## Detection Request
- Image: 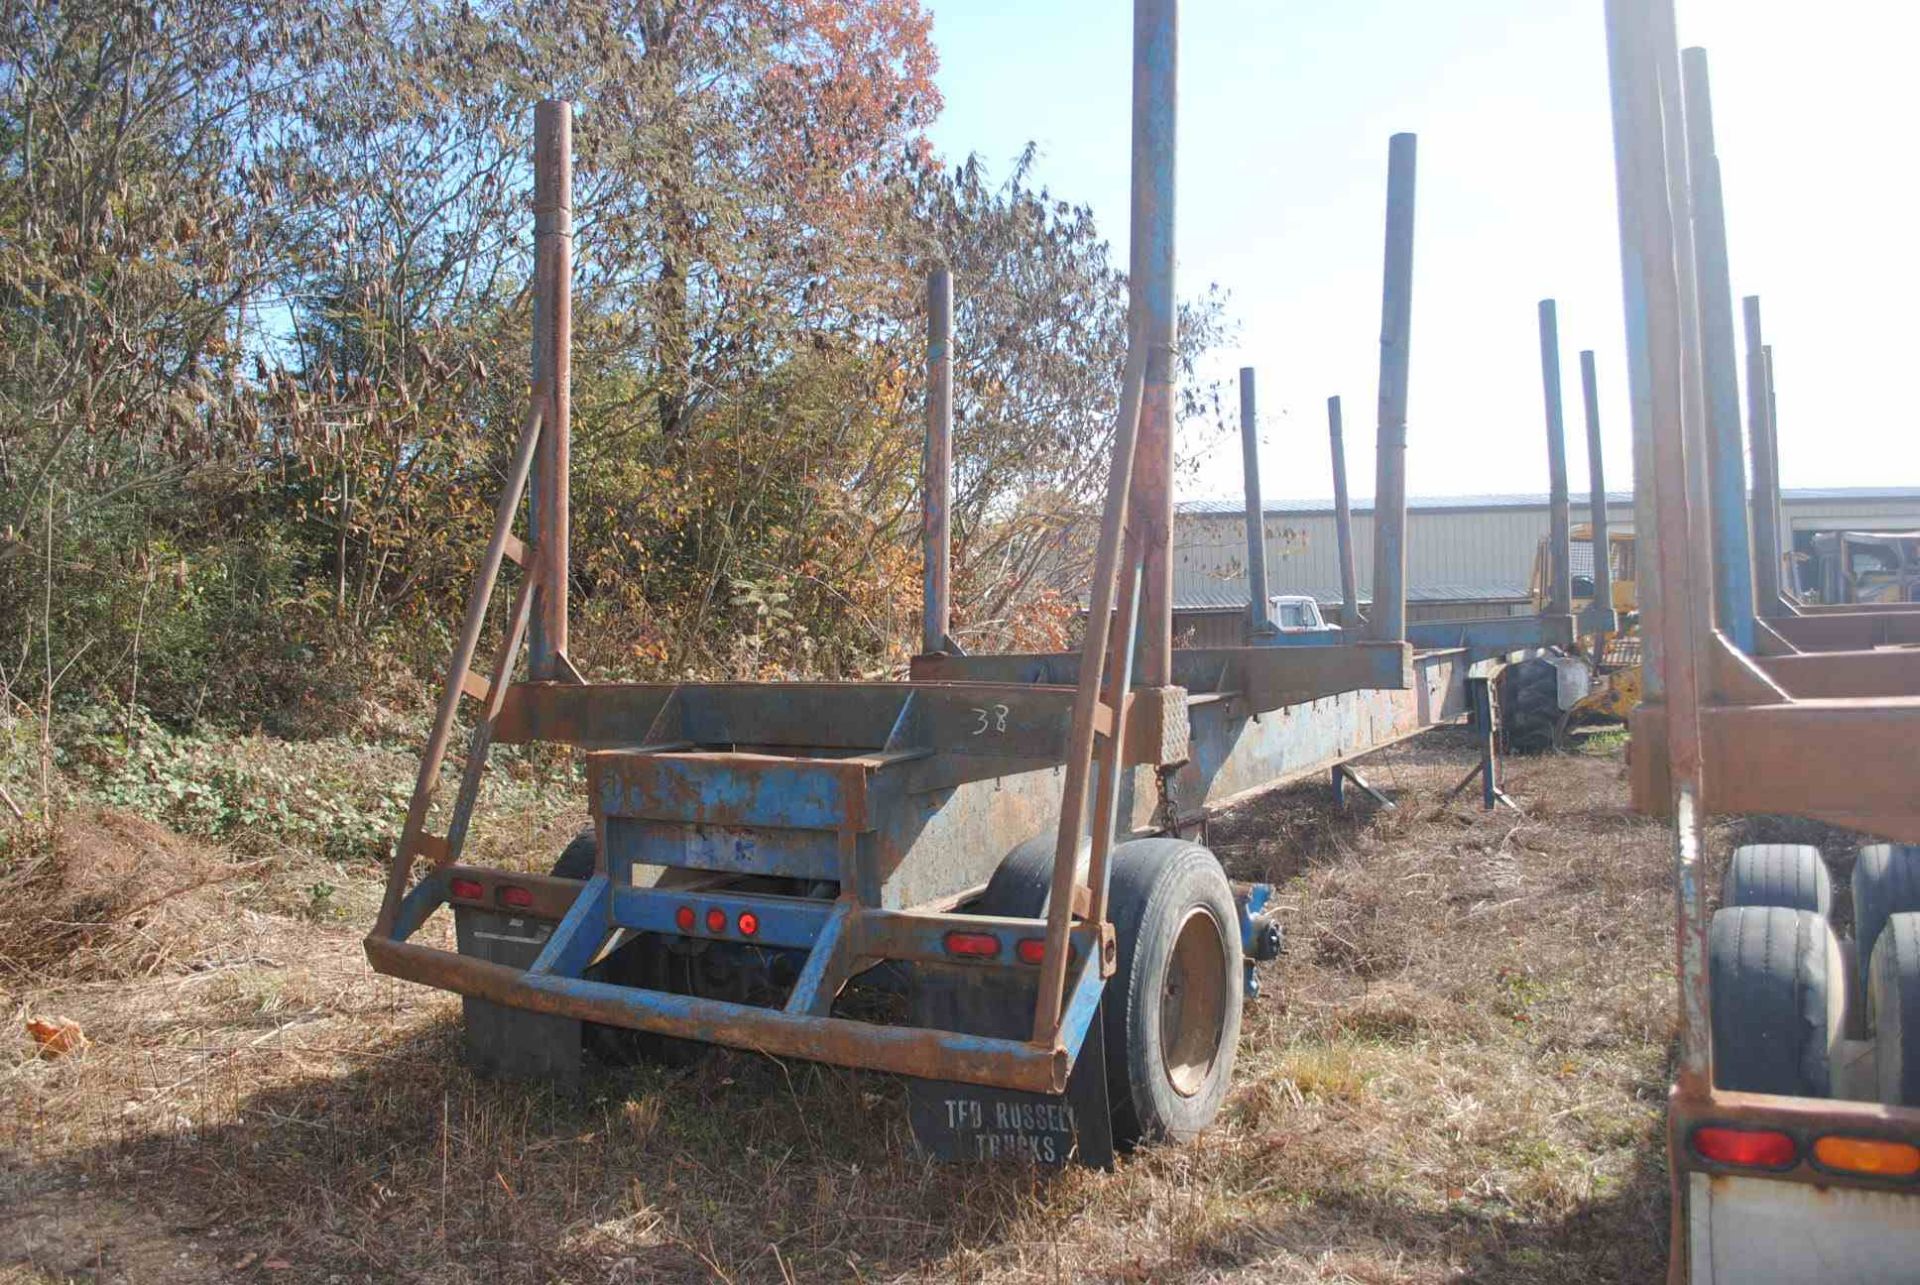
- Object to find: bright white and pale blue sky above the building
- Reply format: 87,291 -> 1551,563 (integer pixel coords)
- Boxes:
927,0 -> 1920,503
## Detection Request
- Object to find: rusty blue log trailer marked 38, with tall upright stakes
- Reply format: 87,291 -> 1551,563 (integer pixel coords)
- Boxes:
367,0 -> 1571,1164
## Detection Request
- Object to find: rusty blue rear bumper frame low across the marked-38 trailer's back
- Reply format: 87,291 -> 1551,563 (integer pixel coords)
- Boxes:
365,872 -> 1106,1093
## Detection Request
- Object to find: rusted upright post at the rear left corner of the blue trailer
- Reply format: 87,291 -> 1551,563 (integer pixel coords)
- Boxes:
528,98 -> 574,678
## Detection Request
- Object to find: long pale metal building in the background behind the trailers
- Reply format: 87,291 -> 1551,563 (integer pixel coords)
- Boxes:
1173,486 -> 1920,645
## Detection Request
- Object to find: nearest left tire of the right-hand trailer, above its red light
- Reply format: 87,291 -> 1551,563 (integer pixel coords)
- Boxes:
1709,907 -> 1847,1097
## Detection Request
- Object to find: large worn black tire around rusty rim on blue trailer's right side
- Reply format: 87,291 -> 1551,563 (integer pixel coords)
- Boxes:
1102,839 -> 1246,1147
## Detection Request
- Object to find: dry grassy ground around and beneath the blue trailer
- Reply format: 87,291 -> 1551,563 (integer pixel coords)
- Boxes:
0,732 -> 1674,1285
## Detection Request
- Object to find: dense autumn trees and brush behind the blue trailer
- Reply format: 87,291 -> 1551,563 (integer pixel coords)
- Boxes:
0,0 -> 1219,730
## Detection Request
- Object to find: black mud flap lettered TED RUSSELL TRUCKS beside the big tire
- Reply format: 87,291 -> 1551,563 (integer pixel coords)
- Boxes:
906,964 -> 1114,1170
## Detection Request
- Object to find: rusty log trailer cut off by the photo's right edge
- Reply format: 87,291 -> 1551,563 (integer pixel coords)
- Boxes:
1605,0 -> 1920,1285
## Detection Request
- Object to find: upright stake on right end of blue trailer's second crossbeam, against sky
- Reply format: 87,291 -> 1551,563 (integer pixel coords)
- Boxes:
1367,134 -> 1419,642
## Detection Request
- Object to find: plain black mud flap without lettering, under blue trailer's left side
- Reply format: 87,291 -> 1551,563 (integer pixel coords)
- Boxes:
453,907 -> 580,1093
